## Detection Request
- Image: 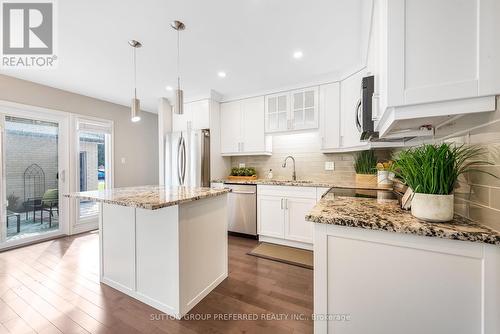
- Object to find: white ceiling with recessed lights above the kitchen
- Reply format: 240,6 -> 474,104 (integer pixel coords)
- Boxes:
0,0 -> 371,112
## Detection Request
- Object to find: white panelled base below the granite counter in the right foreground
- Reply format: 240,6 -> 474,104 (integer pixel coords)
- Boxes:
314,223 -> 500,334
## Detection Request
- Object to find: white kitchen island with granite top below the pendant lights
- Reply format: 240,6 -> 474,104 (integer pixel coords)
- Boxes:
67,186 -> 229,319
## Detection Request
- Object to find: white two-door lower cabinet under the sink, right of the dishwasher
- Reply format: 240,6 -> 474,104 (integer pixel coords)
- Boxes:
257,185 -> 317,249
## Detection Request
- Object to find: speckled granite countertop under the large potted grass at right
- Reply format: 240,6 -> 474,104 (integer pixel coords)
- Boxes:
306,190 -> 500,245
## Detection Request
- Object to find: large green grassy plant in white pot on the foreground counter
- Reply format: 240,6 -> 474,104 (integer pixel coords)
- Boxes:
394,143 -> 494,222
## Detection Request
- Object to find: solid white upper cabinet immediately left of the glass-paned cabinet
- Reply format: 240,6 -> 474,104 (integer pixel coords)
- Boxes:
220,96 -> 272,156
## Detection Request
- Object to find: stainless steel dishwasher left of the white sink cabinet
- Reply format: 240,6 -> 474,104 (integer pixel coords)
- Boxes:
224,184 -> 257,237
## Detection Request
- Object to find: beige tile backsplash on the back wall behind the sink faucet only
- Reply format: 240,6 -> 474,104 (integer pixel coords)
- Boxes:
231,132 -> 390,182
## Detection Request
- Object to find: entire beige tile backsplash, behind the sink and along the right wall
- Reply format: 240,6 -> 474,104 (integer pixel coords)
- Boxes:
231,97 -> 500,231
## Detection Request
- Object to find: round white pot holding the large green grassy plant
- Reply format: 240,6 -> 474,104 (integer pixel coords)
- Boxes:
411,193 -> 454,223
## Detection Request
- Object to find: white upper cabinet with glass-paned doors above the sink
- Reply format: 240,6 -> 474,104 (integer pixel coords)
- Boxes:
265,87 -> 319,132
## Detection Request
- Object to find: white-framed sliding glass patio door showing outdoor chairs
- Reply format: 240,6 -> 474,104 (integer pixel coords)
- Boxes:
0,106 -> 69,249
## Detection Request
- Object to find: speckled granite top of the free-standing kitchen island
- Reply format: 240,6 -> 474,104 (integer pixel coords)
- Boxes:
66,186 -> 230,210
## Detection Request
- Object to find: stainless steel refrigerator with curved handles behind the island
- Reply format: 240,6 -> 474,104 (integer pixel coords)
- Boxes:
165,129 -> 210,187
